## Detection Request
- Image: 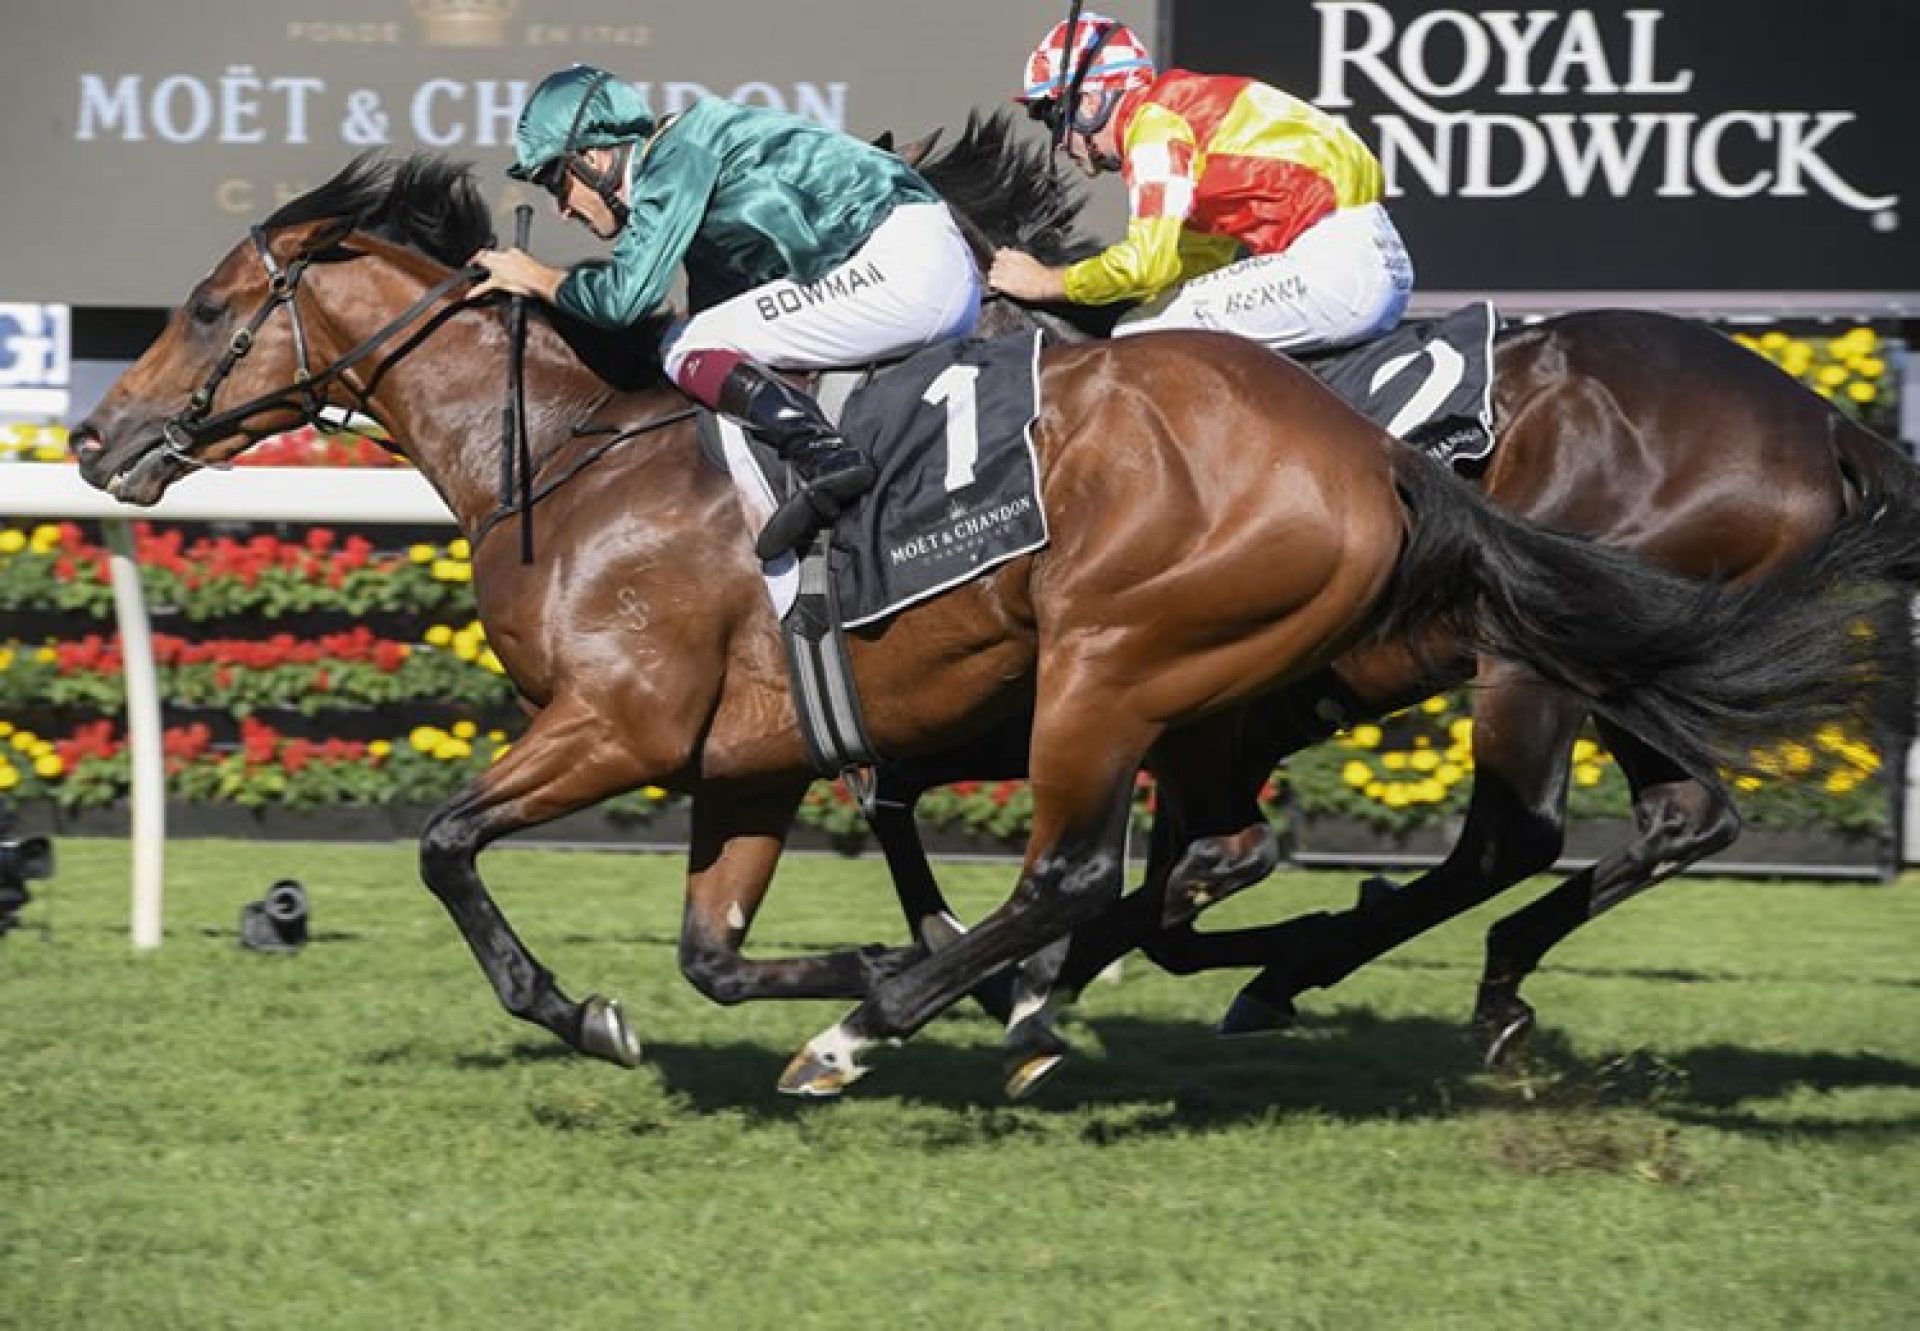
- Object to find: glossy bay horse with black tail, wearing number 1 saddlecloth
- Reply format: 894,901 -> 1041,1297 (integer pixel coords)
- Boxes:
73,157 -> 1880,1093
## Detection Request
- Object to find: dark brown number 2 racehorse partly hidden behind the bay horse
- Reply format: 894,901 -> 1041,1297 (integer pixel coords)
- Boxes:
876,113 -> 1920,1060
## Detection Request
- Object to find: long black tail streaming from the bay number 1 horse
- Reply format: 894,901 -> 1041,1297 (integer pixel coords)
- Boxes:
1382,448 -> 1907,784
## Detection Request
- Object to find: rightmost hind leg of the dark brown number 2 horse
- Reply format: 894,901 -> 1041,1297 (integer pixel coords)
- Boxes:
1473,726 -> 1740,1064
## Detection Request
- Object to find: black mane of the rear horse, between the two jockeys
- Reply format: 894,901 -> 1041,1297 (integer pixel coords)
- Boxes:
918,109 -> 1100,265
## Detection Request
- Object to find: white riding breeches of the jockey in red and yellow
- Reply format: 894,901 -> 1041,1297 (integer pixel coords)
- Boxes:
1114,204 -> 1413,351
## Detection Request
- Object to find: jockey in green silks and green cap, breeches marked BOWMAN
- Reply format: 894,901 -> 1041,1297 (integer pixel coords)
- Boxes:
462,65 -> 981,559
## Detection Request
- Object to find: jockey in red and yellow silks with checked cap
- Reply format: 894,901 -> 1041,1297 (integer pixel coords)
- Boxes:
989,13 -> 1413,351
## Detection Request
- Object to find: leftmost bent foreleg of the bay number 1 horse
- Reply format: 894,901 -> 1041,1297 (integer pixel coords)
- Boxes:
420,701 -> 647,1066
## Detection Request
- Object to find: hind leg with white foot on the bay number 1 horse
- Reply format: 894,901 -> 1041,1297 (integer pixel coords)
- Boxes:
780,668 -> 1154,1095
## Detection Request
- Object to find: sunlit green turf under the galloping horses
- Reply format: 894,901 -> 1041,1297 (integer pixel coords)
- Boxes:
0,841 -> 1920,1331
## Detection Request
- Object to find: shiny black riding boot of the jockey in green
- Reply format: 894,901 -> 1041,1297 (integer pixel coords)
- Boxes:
720,361 -> 874,559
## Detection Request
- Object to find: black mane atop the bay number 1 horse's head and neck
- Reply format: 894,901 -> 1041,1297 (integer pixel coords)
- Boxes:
265,152 -> 493,267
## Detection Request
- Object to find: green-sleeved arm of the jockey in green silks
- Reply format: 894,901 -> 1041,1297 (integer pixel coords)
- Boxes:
553,138 -> 720,328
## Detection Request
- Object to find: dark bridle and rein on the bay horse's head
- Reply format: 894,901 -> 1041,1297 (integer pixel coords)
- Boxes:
159,227 -> 486,471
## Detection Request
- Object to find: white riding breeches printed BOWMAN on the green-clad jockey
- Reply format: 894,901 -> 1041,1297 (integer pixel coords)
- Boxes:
666,204 -> 981,380
